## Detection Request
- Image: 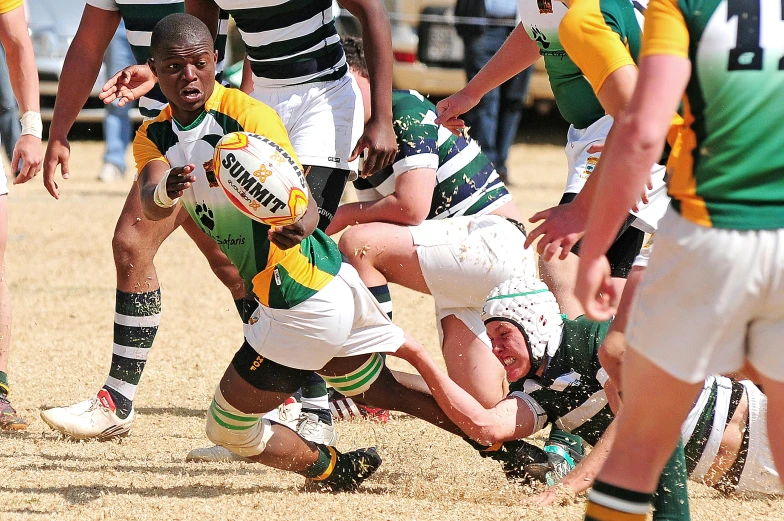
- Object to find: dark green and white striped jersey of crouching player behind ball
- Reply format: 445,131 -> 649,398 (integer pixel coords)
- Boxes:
354,90 -> 512,219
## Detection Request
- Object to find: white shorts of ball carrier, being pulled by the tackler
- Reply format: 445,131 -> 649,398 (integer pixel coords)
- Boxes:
245,263 -> 405,371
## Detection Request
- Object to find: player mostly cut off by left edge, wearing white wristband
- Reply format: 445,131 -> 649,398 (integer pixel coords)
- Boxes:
0,0 -> 43,430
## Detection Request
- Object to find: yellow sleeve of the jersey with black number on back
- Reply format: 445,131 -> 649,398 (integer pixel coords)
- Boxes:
640,0 -> 689,58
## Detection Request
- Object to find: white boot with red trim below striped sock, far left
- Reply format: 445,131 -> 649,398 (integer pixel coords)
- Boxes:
41,389 -> 135,441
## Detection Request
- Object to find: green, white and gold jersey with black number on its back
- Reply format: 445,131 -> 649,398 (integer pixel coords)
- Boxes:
641,0 -> 784,230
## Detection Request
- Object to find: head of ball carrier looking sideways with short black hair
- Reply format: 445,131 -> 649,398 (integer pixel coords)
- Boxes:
149,13 -> 217,119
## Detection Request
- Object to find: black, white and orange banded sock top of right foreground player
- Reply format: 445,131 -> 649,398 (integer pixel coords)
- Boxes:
585,480 -> 653,521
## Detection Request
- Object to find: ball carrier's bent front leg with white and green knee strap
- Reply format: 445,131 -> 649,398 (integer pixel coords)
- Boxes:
206,342 -> 381,491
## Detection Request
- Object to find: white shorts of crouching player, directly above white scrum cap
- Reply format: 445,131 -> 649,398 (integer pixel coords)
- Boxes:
408,215 -> 536,347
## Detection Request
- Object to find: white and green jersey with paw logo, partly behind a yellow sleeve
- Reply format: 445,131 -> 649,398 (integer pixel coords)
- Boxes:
517,0 -> 605,128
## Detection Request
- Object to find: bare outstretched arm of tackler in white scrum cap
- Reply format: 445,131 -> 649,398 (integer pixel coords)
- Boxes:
394,342 -> 537,445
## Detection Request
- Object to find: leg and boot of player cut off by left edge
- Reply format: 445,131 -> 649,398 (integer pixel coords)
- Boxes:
0,193 -> 27,430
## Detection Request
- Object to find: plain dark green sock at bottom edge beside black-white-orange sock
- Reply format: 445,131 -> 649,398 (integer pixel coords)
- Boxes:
653,441 -> 691,521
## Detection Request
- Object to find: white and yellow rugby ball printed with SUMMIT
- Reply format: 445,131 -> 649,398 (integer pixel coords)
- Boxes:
213,132 -> 308,226
